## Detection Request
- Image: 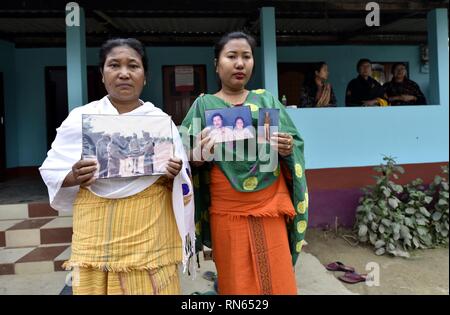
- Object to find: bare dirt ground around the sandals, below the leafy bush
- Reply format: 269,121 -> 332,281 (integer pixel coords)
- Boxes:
304,228 -> 449,295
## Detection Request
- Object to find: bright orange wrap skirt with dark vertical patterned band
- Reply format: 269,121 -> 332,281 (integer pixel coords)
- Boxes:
210,166 -> 297,295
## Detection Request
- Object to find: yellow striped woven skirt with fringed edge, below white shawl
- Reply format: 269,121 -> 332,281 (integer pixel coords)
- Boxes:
64,178 -> 183,294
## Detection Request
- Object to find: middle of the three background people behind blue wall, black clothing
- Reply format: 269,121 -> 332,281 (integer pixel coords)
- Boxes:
345,59 -> 386,106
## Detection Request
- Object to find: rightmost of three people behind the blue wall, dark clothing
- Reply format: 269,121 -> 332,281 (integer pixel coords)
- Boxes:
383,62 -> 427,105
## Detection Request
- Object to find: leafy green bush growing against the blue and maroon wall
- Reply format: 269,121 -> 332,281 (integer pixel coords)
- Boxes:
355,157 -> 448,257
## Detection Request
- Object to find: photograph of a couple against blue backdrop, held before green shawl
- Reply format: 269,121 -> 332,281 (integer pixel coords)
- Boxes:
205,106 -> 255,143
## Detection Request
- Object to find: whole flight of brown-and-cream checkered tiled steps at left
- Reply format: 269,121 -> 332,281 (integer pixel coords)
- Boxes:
0,203 -> 72,275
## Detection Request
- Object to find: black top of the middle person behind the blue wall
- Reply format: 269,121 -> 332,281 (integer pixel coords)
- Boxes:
345,76 -> 384,106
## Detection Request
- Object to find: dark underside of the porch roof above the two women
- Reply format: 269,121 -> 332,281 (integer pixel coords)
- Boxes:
0,0 -> 442,46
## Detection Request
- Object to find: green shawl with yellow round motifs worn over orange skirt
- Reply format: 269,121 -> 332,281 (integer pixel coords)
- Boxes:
182,89 -> 308,264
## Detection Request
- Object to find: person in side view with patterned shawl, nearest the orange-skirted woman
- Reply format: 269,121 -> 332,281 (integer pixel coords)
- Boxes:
300,62 -> 336,107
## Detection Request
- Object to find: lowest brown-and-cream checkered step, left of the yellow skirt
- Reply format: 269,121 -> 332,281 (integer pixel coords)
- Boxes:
0,244 -> 70,275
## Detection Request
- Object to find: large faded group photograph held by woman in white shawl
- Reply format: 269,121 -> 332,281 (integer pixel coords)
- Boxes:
82,115 -> 174,179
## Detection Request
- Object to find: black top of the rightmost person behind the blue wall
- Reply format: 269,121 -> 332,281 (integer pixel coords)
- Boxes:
383,78 -> 427,105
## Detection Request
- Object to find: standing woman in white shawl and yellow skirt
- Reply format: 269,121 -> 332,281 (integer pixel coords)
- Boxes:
40,39 -> 195,294
